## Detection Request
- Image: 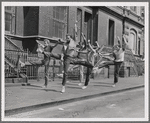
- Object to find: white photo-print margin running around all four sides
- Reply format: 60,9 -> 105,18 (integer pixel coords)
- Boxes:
1,1 -> 149,122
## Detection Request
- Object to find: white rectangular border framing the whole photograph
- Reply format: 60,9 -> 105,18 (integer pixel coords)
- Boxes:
1,0 -> 149,122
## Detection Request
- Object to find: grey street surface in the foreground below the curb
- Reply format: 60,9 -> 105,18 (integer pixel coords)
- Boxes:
6,88 -> 145,118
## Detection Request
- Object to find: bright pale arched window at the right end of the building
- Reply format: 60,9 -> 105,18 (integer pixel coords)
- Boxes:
129,29 -> 138,54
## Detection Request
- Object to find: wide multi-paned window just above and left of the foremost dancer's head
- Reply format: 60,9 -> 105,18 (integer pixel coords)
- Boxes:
53,6 -> 67,39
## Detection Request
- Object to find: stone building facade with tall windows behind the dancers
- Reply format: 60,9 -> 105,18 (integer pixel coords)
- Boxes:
5,6 -> 144,79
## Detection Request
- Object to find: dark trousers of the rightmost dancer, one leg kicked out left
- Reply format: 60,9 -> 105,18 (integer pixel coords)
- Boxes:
99,61 -> 122,83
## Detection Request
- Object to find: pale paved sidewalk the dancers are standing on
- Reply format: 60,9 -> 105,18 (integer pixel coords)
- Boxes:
5,76 -> 144,114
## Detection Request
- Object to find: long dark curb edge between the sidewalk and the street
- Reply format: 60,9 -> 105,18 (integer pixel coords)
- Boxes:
5,85 -> 144,116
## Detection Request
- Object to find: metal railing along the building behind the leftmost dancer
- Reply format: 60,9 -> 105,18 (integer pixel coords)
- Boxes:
5,49 -> 59,80
